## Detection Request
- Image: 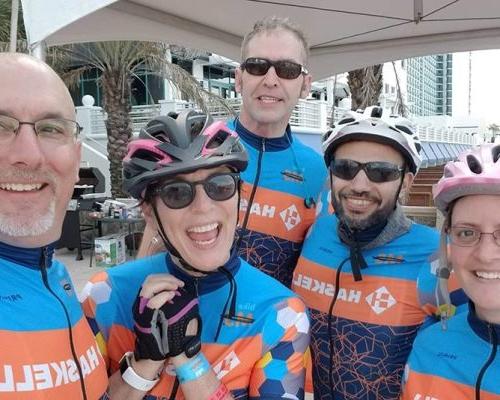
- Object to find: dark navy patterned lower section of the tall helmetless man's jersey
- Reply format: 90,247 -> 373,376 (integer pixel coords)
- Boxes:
237,229 -> 302,287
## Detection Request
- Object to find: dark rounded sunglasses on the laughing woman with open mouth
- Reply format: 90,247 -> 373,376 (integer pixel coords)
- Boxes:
153,172 -> 240,209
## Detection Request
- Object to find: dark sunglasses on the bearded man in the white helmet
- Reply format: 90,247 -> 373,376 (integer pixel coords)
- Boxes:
330,159 -> 404,183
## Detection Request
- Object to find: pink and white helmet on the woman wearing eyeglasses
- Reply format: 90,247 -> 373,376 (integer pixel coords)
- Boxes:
432,144 -> 500,213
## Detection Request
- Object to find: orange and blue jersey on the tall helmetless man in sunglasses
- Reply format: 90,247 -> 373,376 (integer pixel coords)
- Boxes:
228,120 -> 326,287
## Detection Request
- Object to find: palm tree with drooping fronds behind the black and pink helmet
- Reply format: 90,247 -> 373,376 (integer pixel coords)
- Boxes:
53,41 -> 232,197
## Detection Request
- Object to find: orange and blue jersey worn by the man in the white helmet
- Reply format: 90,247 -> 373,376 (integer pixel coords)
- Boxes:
292,208 -> 444,400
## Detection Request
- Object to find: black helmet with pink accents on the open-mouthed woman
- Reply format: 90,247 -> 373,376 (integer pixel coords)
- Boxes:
123,110 -> 248,199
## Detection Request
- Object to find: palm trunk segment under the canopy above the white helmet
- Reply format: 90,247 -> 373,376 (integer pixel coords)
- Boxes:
347,64 -> 383,110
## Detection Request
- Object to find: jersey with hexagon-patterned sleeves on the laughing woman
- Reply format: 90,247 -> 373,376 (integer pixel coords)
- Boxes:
83,253 -> 309,400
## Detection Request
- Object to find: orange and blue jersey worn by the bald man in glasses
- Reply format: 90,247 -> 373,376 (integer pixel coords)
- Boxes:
0,243 -> 108,400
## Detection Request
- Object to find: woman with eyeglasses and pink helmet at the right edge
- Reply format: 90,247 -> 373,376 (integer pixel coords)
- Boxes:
402,144 -> 500,400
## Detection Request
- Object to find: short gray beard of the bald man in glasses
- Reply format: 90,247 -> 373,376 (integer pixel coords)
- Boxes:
0,199 -> 56,237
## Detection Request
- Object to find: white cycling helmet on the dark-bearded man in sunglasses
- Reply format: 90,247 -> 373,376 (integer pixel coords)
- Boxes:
322,107 -> 422,174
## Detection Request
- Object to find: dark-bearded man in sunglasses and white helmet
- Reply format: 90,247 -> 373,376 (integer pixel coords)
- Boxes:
292,108 -> 438,400
